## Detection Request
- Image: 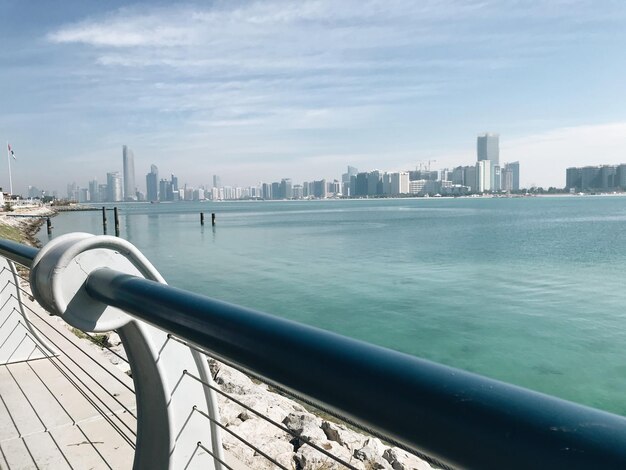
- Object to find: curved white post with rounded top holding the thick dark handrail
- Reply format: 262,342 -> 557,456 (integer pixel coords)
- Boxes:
30,233 -> 223,470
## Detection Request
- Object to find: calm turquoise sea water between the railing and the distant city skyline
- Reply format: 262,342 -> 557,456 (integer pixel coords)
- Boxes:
40,197 -> 626,415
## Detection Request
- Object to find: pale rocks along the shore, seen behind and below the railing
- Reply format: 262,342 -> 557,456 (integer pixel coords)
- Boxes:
0,207 -> 433,470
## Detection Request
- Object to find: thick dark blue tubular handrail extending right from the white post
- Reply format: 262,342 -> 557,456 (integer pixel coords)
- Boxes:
0,241 -> 626,469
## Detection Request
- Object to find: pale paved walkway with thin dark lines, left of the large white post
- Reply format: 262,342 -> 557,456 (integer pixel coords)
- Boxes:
0,284 -> 136,470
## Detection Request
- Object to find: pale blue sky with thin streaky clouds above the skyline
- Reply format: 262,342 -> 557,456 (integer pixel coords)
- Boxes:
0,0 -> 626,194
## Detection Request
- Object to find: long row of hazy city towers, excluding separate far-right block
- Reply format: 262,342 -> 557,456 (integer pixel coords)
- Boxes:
61,133 -> 520,203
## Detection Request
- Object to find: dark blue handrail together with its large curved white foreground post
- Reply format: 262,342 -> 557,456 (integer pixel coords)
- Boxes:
0,234 -> 626,469
